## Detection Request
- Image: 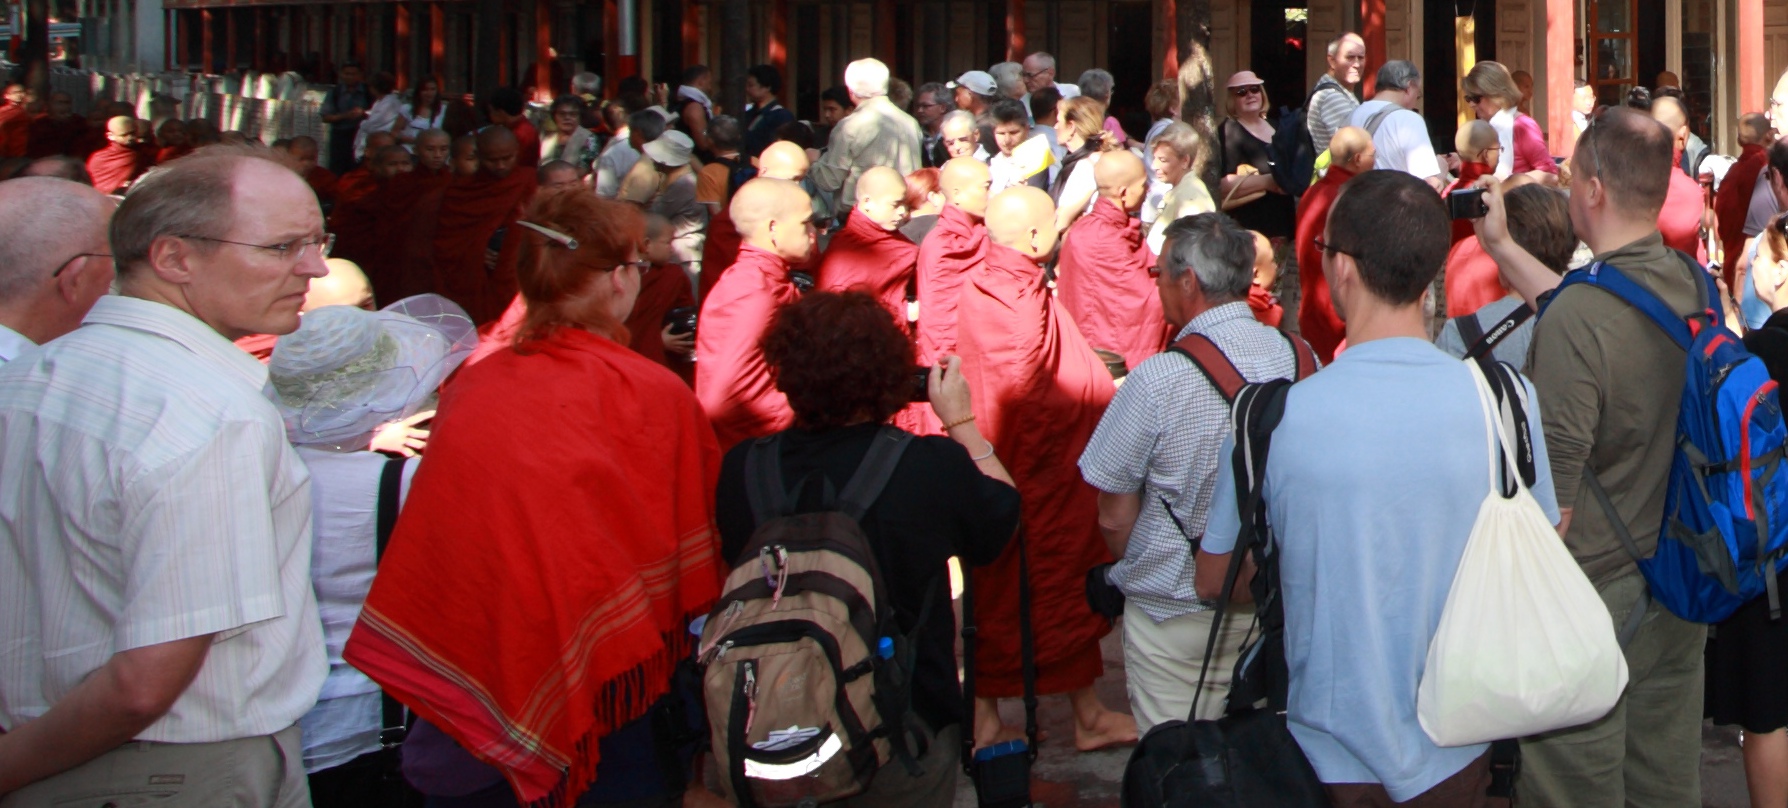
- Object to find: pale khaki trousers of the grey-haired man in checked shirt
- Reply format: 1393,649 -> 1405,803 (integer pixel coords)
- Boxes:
1123,602 -> 1253,735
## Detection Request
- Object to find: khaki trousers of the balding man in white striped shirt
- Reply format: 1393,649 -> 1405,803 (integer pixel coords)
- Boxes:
0,724 -> 311,808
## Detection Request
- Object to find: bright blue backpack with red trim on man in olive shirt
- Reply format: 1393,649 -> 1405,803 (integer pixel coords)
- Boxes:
1554,254 -> 1788,625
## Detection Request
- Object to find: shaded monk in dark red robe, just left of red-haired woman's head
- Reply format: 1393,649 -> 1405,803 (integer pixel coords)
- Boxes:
433,127 -> 535,325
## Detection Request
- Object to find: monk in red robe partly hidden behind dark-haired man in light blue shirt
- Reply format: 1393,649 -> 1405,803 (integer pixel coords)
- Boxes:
1296,127 -> 1379,365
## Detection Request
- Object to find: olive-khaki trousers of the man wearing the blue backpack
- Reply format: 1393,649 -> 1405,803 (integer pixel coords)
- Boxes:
1516,570 -> 1708,808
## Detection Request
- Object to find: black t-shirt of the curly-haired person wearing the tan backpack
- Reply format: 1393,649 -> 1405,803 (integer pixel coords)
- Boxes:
715,424 -> 1019,729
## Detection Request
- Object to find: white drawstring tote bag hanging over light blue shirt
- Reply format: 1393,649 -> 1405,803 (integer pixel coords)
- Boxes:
1416,361 -> 1627,745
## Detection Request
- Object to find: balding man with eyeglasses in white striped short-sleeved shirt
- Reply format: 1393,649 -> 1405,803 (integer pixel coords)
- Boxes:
0,147 -> 329,808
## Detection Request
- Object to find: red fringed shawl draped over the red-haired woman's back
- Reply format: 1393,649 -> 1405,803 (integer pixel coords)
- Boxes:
343,329 -> 726,806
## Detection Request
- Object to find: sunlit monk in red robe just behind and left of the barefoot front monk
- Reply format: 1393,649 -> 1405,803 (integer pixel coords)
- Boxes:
917,157 -> 992,370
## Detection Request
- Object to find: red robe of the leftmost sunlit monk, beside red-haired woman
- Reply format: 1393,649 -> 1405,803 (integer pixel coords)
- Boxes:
696,243 -> 801,450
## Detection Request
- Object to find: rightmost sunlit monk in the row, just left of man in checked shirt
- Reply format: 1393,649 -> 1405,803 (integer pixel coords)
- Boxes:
1055,152 -> 1169,368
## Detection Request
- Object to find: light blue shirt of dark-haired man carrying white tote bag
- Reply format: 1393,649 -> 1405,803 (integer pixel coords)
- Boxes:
1203,338 -> 1559,803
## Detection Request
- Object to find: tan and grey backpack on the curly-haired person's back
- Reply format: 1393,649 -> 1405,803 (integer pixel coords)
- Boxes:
701,427 -> 937,808
